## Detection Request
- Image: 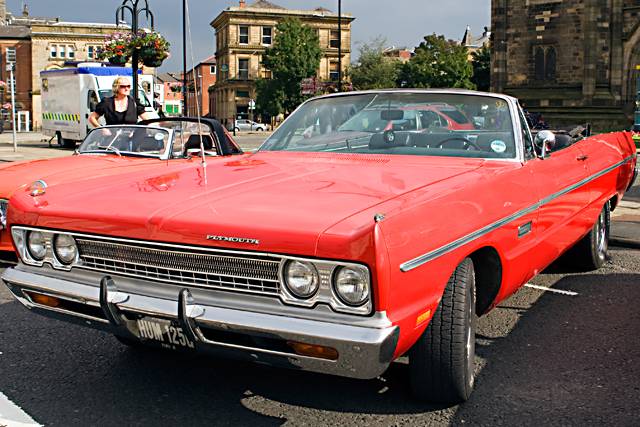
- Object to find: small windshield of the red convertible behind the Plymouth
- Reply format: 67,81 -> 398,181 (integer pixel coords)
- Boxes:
79,126 -> 169,157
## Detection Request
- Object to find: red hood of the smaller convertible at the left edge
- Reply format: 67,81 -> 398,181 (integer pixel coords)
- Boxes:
0,154 -> 168,199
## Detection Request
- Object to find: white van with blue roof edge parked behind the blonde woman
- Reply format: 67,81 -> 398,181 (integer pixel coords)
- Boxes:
40,63 -> 158,148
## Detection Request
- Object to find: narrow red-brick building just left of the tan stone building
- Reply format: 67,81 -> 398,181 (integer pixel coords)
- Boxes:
186,56 -> 217,117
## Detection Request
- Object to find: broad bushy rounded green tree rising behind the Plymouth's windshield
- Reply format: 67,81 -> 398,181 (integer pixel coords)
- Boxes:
398,34 -> 475,89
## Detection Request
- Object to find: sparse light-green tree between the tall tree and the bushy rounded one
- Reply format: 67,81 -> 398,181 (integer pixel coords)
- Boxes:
347,37 -> 400,90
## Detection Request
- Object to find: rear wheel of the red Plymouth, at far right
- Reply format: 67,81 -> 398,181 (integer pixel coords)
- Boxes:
572,202 -> 611,270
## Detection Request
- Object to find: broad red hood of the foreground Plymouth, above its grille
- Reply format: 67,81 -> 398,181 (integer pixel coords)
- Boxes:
10,152 -> 483,254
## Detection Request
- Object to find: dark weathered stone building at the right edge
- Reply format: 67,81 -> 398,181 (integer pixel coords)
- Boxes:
491,0 -> 640,129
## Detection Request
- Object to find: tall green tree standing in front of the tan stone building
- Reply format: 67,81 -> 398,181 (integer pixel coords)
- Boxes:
258,18 -> 322,112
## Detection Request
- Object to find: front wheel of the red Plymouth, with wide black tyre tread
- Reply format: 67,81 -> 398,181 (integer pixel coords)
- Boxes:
409,258 -> 476,403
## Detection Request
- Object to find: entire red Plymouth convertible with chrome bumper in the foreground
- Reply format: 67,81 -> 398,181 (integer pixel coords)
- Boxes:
2,90 -> 637,402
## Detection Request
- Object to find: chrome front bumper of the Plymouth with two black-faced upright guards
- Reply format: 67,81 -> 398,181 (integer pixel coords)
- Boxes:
2,267 -> 399,378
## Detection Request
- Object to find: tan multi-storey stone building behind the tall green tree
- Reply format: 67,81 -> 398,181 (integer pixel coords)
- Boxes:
211,0 -> 355,120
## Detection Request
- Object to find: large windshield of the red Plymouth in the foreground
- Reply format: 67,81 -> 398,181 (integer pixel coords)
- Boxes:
260,92 -> 516,158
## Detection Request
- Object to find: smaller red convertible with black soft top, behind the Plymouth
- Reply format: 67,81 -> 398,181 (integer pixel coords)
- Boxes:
0,117 -> 241,261
